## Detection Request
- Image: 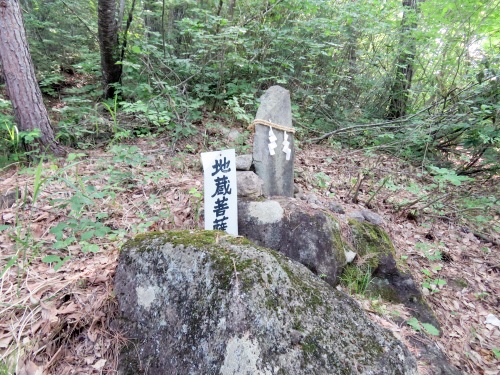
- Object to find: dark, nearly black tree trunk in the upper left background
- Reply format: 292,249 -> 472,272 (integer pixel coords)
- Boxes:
97,0 -> 122,99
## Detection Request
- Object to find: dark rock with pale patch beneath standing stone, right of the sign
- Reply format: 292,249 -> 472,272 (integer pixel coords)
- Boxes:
238,197 -> 350,285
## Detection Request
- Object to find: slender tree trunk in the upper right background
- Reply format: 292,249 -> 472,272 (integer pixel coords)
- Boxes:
386,0 -> 419,119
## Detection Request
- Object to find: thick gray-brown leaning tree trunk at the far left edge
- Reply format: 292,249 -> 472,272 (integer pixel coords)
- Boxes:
0,0 -> 65,156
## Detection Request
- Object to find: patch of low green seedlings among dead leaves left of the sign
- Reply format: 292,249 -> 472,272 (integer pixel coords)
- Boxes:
0,145 -> 176,275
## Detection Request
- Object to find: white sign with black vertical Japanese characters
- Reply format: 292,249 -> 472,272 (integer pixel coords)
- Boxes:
201,149 -> 238,236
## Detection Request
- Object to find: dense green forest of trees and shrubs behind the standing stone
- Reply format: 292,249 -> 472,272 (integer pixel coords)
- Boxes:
0,0 -> 500,229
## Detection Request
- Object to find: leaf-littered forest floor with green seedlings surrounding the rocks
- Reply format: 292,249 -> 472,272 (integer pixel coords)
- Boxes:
0,122 -> 500,375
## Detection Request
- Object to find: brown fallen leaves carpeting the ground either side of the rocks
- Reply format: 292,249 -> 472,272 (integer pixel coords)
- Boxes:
0,140 -> 500,375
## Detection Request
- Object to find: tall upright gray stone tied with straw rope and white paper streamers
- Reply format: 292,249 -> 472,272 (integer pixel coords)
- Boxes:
253,86 -> 295,197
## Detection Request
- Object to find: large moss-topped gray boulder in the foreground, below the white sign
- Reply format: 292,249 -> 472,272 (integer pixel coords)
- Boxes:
115,231 -> 417,375
